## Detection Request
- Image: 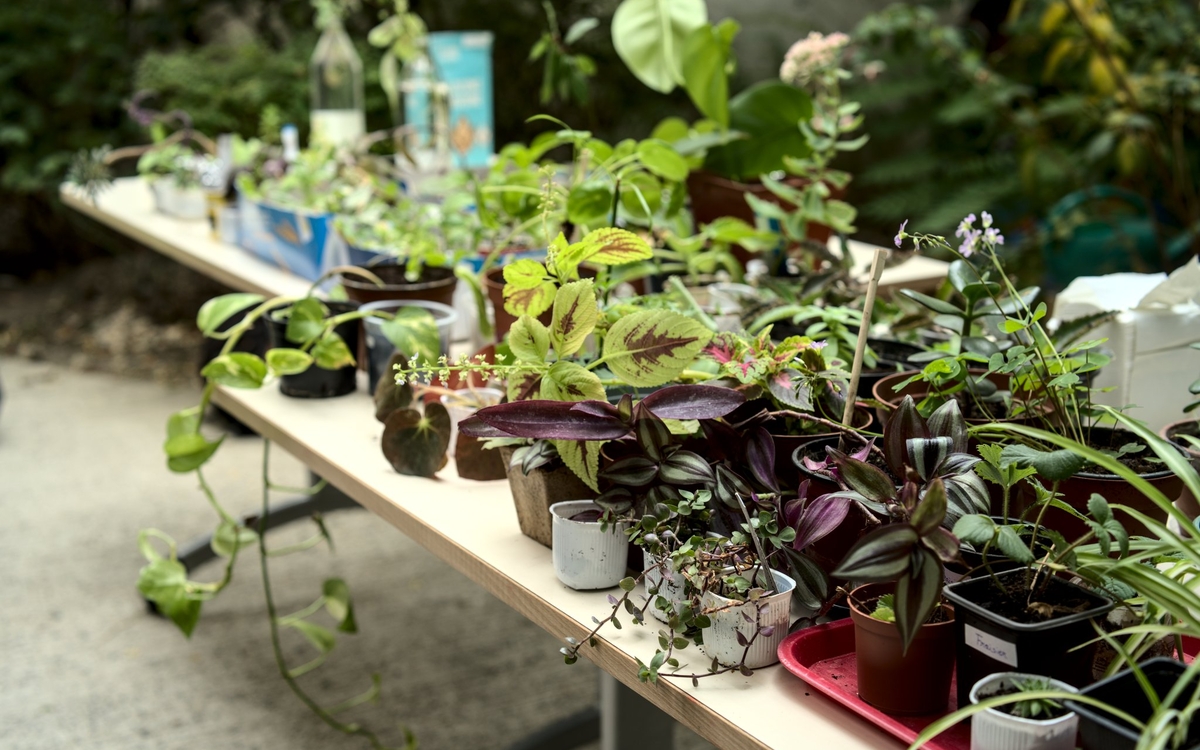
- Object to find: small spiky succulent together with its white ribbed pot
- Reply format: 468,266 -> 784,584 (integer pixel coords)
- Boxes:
971,672 -> 1079,750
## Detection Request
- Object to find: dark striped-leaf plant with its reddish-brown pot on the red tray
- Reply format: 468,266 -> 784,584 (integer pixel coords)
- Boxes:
833,470 -> 959,714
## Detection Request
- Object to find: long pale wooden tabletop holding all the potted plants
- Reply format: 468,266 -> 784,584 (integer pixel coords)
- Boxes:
64,176 -> 931,750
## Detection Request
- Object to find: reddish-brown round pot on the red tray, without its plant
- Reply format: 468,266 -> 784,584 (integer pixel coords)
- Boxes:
850,583 -> 954,715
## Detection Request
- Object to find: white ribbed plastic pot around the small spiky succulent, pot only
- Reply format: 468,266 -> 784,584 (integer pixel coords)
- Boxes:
971,672 -> 1079,750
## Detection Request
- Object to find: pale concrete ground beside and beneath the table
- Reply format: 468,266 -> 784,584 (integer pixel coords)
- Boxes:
0,358 -> 710,750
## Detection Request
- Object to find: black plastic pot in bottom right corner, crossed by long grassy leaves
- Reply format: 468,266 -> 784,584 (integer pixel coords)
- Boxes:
1067,656 -> 1200,750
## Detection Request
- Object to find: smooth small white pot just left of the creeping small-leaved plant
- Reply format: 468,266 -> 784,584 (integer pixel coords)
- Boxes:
550,500 -> 629,592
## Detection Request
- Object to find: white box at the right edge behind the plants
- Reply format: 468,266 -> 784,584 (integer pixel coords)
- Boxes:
1055,258 -> 1200,430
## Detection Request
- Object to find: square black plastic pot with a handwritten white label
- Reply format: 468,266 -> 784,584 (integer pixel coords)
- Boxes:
944,568 -> 1115,706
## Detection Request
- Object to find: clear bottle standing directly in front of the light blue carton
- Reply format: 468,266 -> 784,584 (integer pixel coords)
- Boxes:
400,42 -> 450,174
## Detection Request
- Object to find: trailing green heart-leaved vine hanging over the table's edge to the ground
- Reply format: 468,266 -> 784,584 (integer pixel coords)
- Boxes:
137,268 -> 437,750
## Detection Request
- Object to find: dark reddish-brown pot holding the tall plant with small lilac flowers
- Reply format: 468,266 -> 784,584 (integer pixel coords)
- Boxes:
1010,427 -> 1183,539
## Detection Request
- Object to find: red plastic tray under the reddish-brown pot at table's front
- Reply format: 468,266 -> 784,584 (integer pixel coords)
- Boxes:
779,618 -> 1200,750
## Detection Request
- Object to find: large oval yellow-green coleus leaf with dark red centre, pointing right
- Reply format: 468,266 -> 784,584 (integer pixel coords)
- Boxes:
604,310 -> 712,388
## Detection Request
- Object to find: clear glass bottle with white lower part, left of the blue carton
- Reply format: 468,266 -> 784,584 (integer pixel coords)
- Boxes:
308,18 -> 366,148
